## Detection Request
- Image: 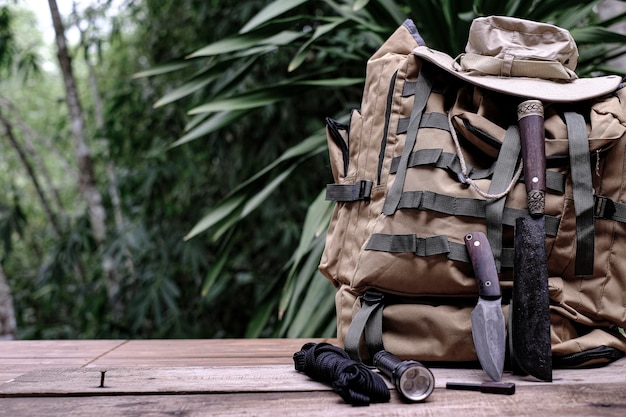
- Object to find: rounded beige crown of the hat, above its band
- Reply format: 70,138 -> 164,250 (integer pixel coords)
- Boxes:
465,16 -> 578,71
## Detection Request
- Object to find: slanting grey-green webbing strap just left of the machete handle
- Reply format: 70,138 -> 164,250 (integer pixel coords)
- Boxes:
485,125 -> 521,271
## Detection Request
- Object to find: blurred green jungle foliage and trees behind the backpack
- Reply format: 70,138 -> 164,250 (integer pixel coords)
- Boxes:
0,0 -> 626,339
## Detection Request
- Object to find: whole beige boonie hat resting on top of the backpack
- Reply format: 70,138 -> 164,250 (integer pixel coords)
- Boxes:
413,16 -> 622,102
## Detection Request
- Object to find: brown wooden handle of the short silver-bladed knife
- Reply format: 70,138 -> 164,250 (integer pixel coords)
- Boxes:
465,232 -> 501,299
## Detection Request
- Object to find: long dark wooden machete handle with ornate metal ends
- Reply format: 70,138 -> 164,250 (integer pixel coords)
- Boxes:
517,100 -> 546,216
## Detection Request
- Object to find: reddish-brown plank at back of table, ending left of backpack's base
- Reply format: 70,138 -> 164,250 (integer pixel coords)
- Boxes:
89,339 -> 336,366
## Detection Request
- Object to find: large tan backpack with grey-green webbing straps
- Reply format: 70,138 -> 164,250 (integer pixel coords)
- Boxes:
319,19 -> 626,367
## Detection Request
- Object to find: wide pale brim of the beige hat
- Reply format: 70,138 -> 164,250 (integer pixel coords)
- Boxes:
413,46 -> 622,102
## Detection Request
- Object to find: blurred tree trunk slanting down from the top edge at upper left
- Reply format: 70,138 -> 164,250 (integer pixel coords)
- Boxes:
48,0 -> 106,245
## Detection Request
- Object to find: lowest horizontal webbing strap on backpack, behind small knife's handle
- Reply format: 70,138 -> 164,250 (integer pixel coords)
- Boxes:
365,233 -> 514,268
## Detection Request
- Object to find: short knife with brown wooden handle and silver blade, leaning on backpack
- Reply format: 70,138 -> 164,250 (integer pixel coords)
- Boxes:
465,232 -> 506,382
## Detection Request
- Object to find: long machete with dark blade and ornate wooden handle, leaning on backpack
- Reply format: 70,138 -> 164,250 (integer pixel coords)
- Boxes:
509,100 -> 552,381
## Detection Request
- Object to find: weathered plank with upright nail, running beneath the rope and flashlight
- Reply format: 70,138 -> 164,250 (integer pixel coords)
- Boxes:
0,360 -> 626,396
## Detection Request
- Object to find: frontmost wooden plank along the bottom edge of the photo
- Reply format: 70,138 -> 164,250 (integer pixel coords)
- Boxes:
2,383 -> 626,417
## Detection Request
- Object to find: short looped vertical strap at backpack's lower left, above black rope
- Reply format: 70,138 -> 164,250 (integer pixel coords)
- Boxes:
344,290 -> 384,361
